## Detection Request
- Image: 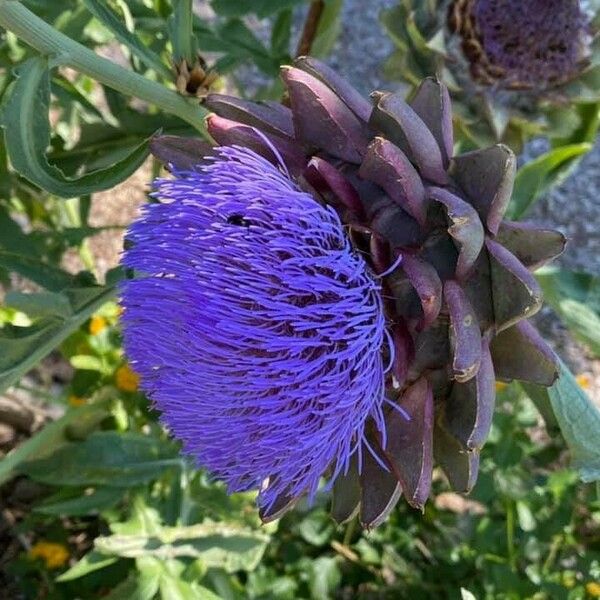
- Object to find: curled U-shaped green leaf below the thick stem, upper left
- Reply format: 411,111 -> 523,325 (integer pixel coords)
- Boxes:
0,57 -> 149,198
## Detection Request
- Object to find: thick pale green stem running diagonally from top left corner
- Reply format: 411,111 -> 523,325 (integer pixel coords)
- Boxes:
0,0 -> 208,138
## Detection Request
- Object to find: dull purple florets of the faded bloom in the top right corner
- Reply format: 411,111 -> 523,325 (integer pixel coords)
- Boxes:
474,0 -> 588,87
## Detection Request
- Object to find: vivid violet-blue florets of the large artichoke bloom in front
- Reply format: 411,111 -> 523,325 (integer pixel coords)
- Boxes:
122,147 -> 385,507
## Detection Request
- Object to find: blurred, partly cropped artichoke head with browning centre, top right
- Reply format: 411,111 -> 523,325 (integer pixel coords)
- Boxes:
382,0 -> 600,150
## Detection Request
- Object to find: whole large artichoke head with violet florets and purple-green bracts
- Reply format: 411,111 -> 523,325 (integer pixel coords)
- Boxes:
122,58 -> 564,527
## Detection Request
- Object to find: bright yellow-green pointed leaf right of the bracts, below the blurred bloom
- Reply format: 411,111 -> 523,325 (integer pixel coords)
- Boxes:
508,143 -> 592,220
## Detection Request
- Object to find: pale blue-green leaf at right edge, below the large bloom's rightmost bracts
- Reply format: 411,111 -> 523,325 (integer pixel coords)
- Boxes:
548,361 -> 600,482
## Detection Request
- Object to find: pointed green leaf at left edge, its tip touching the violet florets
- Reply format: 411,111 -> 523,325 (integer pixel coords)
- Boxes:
0,278 -> 116,393
